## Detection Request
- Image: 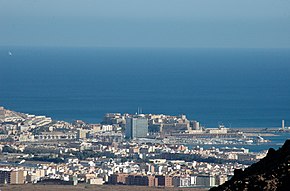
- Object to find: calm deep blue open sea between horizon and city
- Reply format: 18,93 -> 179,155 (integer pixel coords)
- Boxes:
0,47 -> 290,127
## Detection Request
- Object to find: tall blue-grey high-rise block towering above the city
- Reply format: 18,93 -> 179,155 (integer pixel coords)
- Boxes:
125,116 -> 148,139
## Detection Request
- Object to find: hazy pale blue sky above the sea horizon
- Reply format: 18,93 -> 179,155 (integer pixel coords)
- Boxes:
0,0 -> 290,48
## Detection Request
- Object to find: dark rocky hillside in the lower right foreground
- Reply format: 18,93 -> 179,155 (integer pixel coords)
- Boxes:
210,140 -> 290,191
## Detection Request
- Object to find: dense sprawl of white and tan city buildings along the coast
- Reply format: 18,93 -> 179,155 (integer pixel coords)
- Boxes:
0,107 -> 265,187
